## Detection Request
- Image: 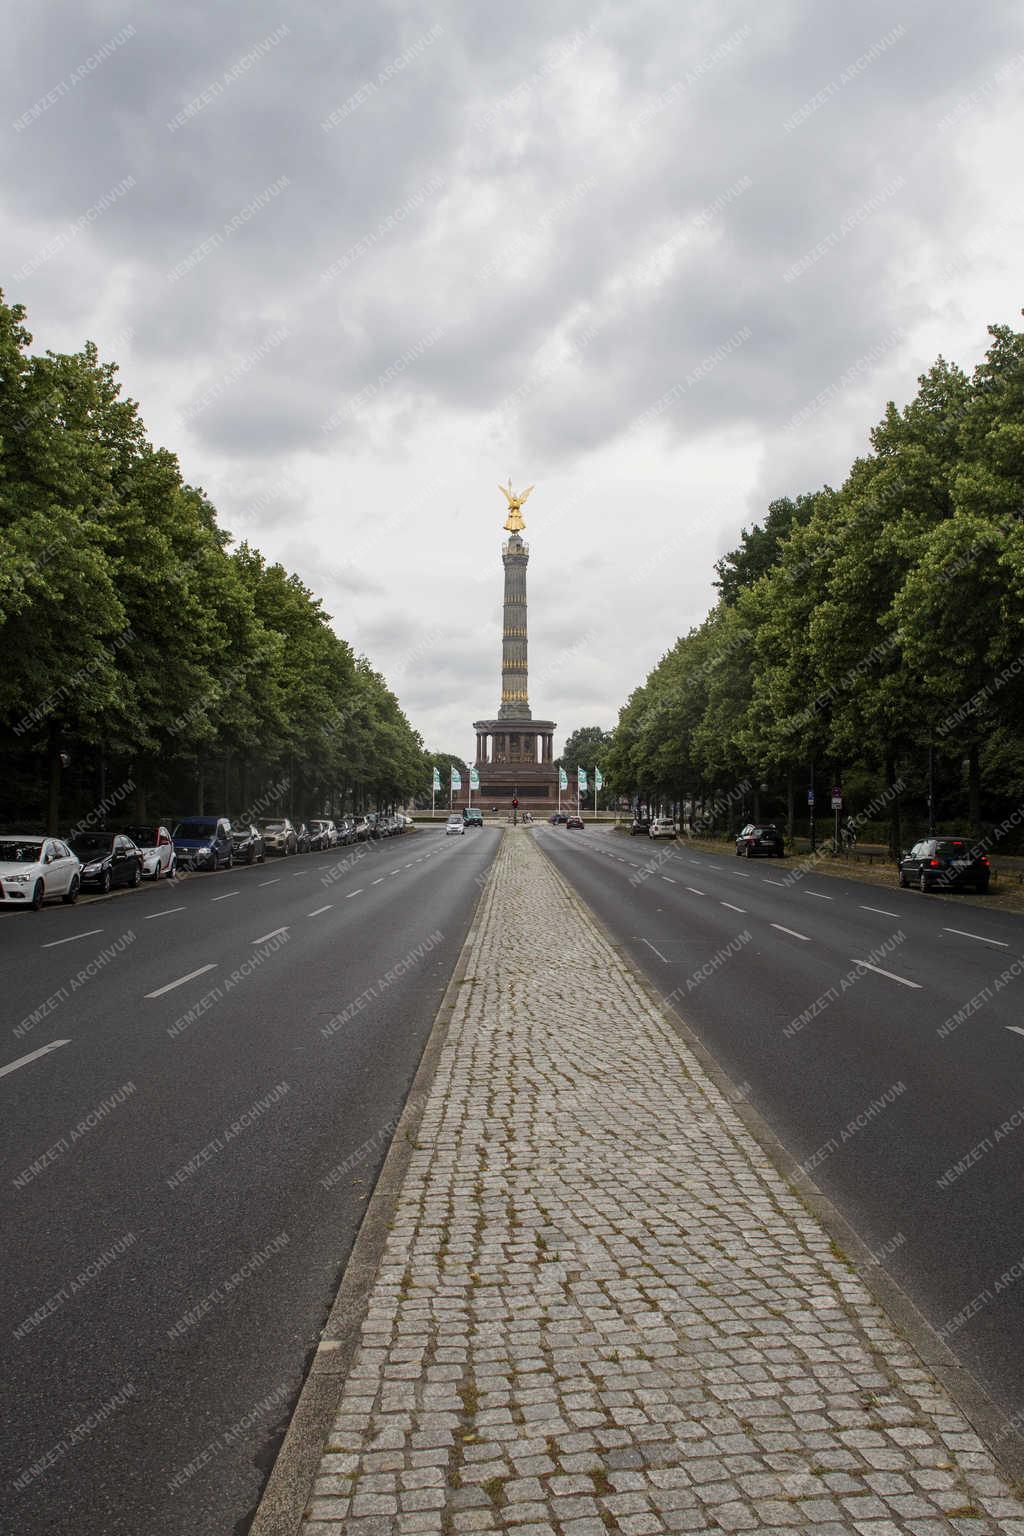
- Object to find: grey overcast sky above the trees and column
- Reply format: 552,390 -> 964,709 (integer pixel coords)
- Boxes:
0,0 -> 1024,754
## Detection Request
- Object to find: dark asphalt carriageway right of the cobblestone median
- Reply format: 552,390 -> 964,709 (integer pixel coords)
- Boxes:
534,826 -> 1024,1415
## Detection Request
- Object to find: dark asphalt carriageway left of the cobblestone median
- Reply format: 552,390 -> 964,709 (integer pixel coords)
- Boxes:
0,828 -> 499,1536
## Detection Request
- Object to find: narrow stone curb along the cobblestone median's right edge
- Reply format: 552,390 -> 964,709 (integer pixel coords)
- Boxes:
534,837 -> 1024,1490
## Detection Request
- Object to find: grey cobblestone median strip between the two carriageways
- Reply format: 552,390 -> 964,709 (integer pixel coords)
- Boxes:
301,833 -> 1024,1536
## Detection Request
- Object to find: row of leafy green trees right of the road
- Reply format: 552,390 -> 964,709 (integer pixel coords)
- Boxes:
608,311 -> 1024,851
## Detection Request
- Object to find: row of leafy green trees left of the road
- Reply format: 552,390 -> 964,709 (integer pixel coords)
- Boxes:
0,293 -> 430,831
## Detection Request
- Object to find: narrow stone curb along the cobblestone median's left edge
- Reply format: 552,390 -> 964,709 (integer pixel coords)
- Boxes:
249,834 -> 504,1536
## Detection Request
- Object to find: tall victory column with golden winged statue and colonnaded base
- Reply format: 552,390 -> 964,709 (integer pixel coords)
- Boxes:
454,481 -> 559,814
